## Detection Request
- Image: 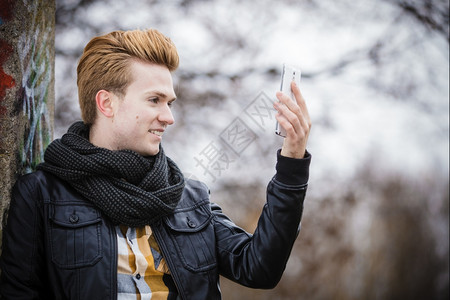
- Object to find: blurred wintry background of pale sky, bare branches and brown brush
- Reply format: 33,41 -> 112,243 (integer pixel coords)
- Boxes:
55,0 -> 449,300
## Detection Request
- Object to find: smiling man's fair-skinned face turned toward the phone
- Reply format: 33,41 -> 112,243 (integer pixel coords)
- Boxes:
111,61 -> 176,156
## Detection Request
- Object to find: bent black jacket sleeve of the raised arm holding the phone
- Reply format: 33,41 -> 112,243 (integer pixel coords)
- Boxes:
212,152 -> 311,288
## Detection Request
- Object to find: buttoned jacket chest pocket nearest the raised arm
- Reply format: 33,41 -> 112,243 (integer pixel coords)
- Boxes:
164,207 -> 217,272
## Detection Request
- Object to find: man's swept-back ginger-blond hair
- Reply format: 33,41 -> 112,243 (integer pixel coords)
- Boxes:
77,29 -> 179,125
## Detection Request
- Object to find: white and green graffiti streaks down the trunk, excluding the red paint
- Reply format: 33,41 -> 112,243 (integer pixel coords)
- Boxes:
17,0 -> 53,172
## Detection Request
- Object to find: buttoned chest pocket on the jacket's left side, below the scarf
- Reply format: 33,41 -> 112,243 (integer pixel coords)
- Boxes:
49,204 -> 102,269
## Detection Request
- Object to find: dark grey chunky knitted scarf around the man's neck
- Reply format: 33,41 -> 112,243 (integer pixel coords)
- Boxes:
38,122 -> 184,227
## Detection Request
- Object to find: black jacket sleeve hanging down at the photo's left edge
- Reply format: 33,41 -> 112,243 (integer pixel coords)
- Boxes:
0,175 -> 46,299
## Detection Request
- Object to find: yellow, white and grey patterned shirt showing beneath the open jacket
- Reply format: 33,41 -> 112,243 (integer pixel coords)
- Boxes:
116,226 -> 179,300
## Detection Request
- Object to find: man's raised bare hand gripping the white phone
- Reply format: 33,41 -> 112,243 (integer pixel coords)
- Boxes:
274,82 -> 311,158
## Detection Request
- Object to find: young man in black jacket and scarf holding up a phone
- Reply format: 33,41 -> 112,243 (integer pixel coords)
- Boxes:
0,30 -> 311,299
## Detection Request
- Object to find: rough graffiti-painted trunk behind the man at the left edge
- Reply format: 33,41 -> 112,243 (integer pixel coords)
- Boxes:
0,0 -> 55,249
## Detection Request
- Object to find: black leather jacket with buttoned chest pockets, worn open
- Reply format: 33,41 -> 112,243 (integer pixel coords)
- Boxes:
0,154 -> 309,299
